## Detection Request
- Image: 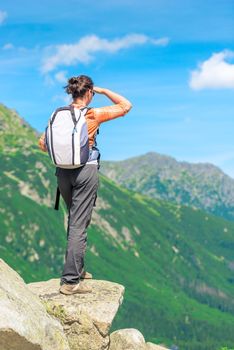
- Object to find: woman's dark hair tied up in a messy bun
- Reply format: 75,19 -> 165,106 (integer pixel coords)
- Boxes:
64,75 -> 93,99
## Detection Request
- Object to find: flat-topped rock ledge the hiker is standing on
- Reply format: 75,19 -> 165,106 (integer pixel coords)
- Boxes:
28,279 -> 124,350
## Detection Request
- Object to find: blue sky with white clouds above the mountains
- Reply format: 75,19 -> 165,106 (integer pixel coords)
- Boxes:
0,0 -> 234,177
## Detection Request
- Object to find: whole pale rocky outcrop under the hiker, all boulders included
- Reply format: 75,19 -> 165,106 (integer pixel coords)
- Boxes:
0,259 -> 168,350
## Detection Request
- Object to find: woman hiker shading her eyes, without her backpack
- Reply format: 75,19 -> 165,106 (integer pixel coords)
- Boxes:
39,75 -> 132,294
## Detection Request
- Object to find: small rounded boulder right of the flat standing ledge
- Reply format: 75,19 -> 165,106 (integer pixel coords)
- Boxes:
109,328 -> 147,350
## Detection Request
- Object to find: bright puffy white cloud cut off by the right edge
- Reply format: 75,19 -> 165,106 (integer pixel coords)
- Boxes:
189,50 -> 234,90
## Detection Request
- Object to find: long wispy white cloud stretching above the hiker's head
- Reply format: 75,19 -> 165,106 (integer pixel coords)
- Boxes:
42,34 -> 168,73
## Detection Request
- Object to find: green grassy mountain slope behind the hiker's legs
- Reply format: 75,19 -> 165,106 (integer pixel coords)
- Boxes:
0,105 -> 234,350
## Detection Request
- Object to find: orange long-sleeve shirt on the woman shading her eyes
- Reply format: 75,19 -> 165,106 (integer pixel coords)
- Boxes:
38,98 -> 132,152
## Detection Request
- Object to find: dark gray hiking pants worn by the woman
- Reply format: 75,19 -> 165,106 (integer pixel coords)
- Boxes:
55,164 -> 99,285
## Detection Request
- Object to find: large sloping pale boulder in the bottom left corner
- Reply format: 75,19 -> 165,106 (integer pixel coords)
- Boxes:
0,259 -> 69,350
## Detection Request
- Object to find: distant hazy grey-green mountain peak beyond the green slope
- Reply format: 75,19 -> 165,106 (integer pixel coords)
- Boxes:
100,152 -> 234,220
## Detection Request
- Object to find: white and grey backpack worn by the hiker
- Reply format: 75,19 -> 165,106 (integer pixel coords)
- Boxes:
45,106 -> 90,169
